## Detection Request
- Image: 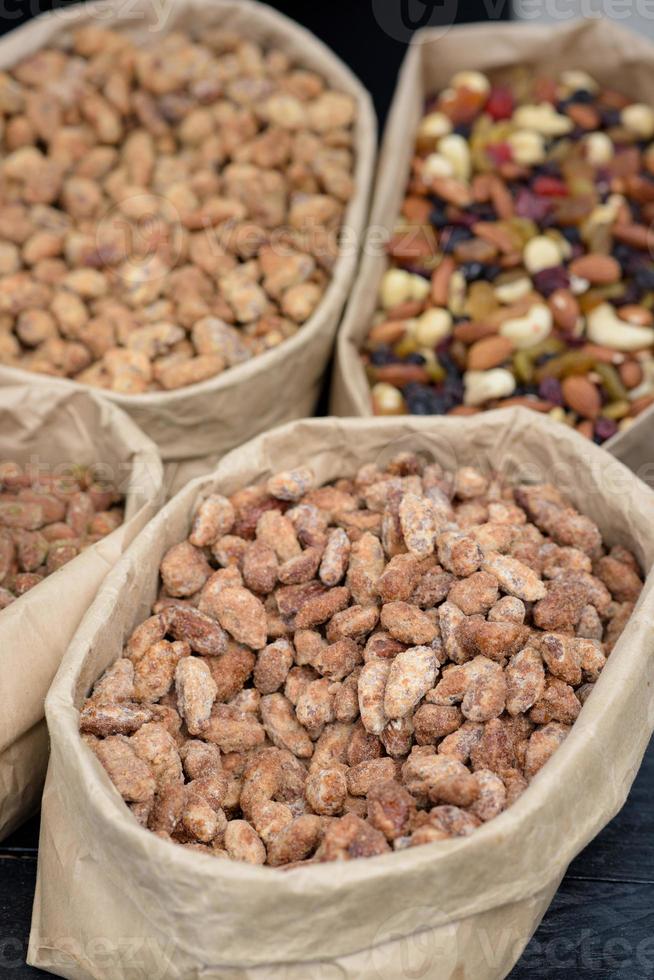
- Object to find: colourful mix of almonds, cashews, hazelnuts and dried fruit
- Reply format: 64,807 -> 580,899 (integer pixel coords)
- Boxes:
362,69 -> 654,443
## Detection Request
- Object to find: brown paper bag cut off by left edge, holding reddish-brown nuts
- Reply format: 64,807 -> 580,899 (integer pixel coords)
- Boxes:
0,383 -> 162,839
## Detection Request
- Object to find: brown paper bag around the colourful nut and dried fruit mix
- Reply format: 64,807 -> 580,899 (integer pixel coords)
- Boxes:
331,19 -> 654,456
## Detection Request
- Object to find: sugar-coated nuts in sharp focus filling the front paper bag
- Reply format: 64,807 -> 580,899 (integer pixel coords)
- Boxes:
80,453 -> 642,866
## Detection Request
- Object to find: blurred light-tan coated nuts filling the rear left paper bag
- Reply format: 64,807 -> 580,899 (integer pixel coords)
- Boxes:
0,27 -> 356,394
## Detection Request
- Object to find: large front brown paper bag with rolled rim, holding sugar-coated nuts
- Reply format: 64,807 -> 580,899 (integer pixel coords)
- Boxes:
28,409 -> 654,980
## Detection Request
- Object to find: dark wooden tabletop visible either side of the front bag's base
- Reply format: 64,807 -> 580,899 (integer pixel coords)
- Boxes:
0,742 -> 654,980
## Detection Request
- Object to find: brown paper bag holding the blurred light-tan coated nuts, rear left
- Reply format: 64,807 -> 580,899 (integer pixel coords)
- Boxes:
0,0 -> 377,468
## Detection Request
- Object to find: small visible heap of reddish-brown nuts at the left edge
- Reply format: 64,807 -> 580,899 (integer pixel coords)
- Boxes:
0,460 -> 124,609
